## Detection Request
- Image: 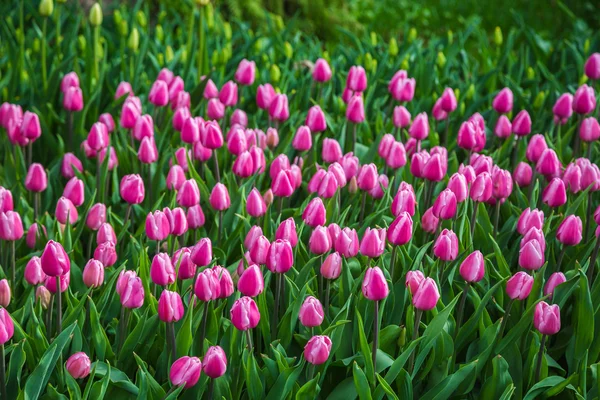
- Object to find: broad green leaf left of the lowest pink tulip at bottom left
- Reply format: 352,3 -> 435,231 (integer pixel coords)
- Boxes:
24,323 -> 75,400
